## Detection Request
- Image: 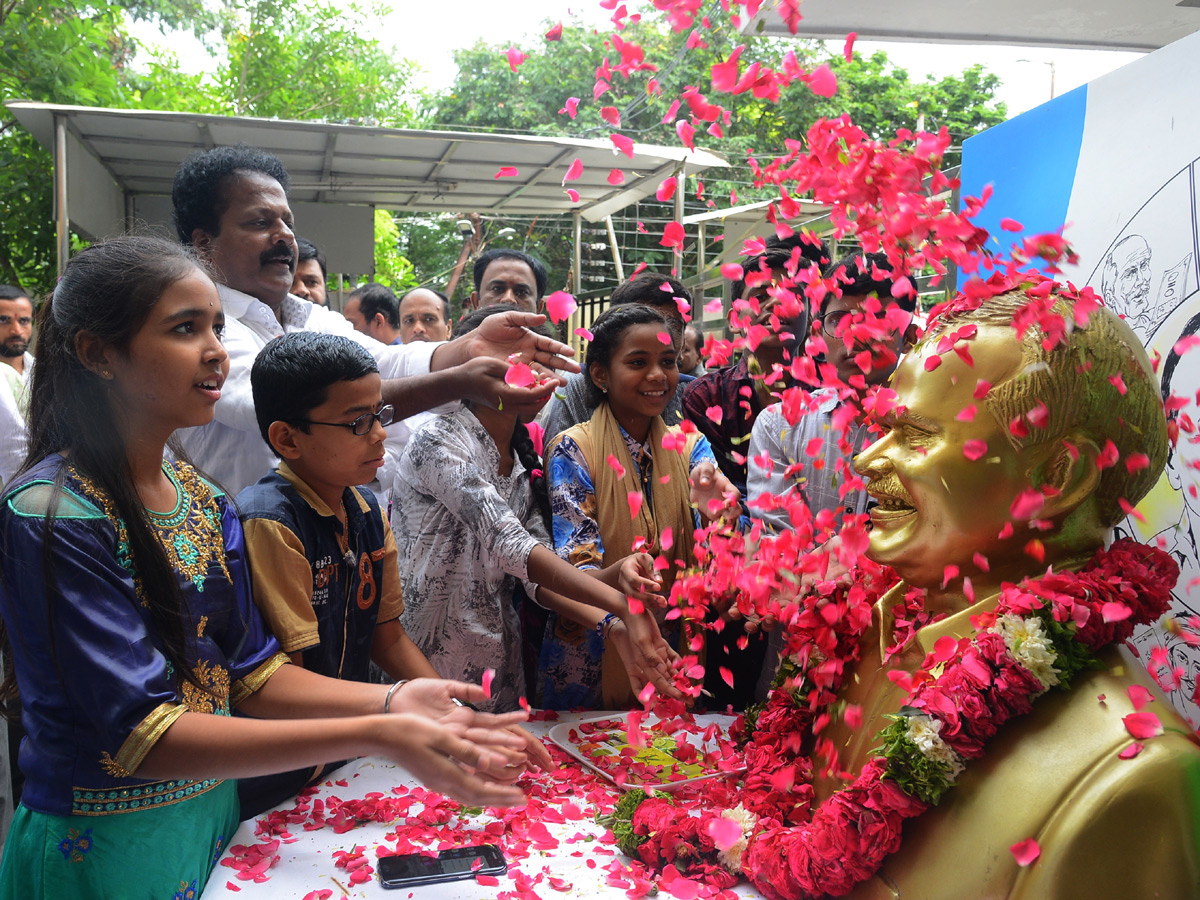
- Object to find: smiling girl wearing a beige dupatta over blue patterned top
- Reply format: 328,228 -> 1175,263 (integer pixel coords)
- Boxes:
539,306 -> 737,709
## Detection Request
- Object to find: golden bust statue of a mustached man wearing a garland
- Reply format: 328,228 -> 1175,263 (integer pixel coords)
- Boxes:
816,292 -> 1200,900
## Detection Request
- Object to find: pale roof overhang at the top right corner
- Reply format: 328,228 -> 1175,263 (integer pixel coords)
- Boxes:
744,0 -> 1200,50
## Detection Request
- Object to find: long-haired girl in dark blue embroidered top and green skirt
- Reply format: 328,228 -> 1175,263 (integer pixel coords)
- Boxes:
0,238 -> 523,900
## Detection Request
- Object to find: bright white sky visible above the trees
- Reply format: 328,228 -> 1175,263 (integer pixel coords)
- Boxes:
133,0 -> 1141,115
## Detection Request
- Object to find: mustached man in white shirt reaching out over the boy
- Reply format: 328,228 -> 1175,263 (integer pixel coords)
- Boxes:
172,145 -> 578,492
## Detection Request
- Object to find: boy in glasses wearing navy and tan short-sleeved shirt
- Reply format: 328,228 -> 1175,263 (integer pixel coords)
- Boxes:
231,331 -> 550,818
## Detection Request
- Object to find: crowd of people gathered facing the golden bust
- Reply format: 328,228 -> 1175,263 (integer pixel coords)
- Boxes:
0,146 -> 1012,896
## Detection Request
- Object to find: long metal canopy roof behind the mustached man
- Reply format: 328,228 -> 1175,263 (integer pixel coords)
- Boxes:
5,101 -> 727,222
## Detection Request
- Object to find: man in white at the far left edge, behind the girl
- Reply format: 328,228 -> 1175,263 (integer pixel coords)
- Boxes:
0,284 -> 34,487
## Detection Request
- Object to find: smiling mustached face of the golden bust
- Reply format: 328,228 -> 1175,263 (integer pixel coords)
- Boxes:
854,328 -> 1033,587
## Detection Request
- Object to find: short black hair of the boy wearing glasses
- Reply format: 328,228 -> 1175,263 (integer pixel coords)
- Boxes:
250,331 -> 379,456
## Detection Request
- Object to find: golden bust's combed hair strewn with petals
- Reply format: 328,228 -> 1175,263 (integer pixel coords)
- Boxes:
923,292 -> 1168,527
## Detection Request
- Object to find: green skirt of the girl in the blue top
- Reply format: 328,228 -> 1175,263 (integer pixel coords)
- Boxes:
0,780 -> 238,900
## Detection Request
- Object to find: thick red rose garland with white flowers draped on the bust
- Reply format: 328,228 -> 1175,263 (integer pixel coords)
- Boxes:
613,540 -> 1178,900
